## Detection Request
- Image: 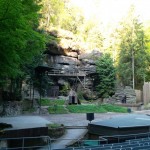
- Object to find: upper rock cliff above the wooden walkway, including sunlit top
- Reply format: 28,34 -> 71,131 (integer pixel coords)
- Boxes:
46,30 -> 101,74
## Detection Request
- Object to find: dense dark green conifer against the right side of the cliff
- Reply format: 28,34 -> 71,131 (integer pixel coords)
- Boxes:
94,54 -> 115,98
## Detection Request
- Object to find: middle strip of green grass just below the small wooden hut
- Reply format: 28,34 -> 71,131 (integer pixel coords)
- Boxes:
67,105 -> 107,113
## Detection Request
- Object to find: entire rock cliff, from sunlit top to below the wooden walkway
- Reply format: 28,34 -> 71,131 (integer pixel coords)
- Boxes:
45,29 -> 101,99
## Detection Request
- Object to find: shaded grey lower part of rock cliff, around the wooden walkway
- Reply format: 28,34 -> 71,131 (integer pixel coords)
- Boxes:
46,50 -> 100,99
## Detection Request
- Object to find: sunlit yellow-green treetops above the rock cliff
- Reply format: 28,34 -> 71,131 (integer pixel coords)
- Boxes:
40,0 -> 103,50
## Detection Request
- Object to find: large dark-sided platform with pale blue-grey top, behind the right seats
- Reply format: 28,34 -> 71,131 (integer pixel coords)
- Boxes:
88,114 -> 150,136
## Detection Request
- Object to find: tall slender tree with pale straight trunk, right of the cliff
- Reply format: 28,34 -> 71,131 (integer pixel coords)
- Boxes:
118,6 -> 147,88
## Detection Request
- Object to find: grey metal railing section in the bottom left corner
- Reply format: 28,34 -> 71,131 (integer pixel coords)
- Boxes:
0,136 -> 51,150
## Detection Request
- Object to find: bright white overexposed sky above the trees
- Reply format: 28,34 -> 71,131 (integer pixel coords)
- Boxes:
71,0 -> 150,24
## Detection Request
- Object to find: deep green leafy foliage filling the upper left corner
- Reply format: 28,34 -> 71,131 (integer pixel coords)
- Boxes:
0,0 -> 45,83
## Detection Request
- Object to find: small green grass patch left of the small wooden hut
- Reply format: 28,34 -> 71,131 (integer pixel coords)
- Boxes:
48,105 -> 68,114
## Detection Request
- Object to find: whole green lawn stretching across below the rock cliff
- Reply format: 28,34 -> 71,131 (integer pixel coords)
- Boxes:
41,99 -> 127,114
